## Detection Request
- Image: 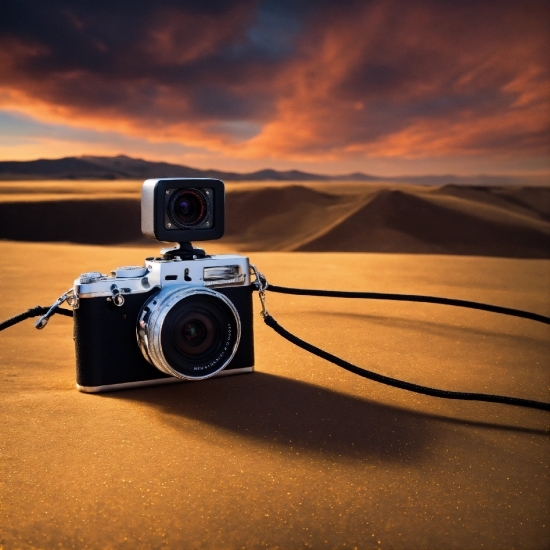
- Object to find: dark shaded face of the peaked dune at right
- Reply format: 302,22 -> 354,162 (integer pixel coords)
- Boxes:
296,190 -> 550,258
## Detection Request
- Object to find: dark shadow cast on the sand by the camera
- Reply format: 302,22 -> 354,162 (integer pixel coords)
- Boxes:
104,372 -> 548,463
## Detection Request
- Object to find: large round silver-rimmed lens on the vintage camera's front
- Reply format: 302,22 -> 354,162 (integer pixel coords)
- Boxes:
138,287 -> 240,379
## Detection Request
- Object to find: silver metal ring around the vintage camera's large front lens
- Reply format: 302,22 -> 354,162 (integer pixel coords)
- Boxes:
137,286 -> 241,380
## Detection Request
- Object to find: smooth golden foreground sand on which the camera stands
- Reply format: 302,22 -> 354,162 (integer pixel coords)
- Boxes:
0,243 -> 550,549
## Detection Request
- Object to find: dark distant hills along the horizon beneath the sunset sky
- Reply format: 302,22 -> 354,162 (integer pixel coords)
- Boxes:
0,155 -> 550,186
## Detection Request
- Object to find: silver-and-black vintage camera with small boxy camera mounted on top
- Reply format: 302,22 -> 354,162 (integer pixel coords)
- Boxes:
73,178 -> 254,392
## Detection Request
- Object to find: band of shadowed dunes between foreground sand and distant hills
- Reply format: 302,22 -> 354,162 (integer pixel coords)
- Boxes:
0,181 -> 550,258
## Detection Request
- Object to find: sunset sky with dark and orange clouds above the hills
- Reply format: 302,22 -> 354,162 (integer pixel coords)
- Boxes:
0,0 -> 550,176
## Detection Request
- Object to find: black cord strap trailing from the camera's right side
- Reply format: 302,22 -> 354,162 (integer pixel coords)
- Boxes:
251,266 -> 550,411
